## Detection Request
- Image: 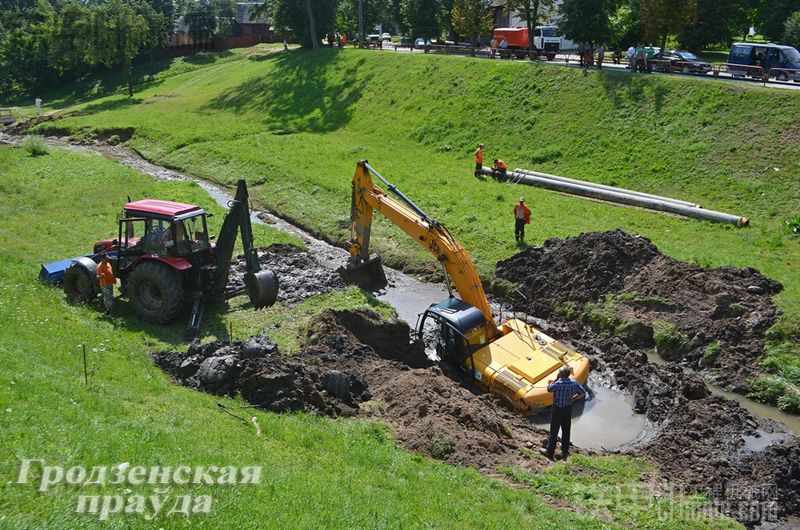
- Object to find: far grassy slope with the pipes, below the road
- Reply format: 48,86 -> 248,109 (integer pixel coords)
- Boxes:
28,45 -> 800,402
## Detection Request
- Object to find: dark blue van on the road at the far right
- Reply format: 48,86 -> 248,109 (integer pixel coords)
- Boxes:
728,42 -> 800,83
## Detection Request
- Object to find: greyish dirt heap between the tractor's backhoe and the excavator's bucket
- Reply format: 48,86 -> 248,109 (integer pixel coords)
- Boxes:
228,244 -> 345,305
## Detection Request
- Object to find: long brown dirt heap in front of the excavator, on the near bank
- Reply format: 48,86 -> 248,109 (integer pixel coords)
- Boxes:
153,310 -> 546,472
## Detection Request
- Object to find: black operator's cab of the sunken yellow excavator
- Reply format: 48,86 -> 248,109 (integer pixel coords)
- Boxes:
417,297 -> 488,366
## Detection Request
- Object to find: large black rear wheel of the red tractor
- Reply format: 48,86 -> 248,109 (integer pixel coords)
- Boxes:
127,261 -> 187,324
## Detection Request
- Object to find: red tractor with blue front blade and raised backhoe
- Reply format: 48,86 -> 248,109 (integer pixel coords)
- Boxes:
40,180 -> 278,334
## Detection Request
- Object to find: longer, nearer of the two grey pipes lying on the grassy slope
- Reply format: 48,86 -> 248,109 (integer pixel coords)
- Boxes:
483,168 -> 750,227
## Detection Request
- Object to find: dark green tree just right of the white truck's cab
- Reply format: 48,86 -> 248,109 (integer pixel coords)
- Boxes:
558,0 -> 619,43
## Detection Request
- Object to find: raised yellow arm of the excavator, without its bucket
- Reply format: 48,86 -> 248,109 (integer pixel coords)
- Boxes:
346,160 -> 499,338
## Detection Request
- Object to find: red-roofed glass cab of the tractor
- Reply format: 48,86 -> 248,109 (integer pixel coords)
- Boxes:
119,199 -> 211,261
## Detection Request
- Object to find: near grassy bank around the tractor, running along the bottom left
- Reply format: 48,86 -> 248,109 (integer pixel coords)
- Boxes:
0,142 -> 731,528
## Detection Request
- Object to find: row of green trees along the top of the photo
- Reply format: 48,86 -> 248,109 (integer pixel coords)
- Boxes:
0,0 -> 800,98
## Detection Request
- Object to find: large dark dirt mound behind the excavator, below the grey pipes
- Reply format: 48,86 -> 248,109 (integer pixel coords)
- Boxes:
497,230 -> 782,392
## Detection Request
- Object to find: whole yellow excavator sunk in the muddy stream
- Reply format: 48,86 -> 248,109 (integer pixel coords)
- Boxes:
341,160 -> 589,414
